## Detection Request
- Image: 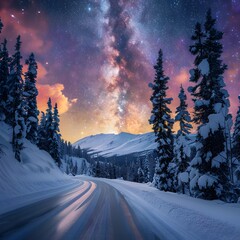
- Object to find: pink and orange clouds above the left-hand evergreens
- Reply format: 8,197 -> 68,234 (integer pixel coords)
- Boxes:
0,9 -> 77,114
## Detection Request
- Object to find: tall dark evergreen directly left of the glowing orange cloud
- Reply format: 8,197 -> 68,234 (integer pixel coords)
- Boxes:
23,53 -> 39,144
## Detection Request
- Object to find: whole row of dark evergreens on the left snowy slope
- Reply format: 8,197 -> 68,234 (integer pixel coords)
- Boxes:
0,19 -> 76,166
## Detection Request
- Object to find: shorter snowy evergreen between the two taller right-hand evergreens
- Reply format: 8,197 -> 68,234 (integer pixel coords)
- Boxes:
174,85 -> 192,193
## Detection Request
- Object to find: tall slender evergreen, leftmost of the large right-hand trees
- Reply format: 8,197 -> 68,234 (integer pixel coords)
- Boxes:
149,50 -> 174,191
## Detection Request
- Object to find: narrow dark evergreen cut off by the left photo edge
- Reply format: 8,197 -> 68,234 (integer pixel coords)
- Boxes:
0,39 -> 10,120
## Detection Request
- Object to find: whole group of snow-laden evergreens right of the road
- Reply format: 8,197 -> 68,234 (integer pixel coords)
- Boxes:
149,10 -> 240,202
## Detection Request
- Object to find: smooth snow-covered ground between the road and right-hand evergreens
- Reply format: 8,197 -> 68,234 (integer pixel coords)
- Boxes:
96,176 -> 240,240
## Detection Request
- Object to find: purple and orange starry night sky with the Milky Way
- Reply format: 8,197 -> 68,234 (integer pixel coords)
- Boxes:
0,0 -> 240,142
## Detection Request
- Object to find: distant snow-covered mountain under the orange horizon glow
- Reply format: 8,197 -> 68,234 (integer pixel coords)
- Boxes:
73,132 -> 157,157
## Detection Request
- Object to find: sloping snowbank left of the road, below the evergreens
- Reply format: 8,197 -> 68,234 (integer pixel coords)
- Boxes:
0,122 -> 79,213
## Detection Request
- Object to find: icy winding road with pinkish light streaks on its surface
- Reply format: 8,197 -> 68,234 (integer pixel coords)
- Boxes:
0,180 -> 181,240
